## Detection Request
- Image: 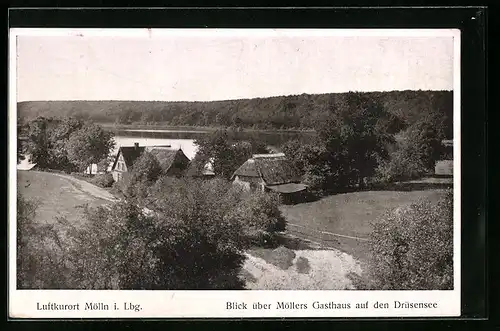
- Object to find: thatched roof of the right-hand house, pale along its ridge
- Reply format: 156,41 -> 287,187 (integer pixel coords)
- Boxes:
232,153 -> 301,185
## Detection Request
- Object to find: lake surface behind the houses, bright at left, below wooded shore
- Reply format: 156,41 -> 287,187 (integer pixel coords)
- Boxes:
107,128 -> 314,159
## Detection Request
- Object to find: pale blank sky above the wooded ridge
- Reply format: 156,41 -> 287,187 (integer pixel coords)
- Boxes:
16,30 -> 453,101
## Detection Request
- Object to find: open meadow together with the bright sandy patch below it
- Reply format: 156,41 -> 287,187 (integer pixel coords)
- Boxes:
244,188 -> 450,290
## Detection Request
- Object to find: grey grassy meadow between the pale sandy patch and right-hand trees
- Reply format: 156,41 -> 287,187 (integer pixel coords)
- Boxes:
281,189 -> 444,263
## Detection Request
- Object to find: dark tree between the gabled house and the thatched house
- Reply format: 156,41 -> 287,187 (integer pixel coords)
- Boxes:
194,130 -> 268,179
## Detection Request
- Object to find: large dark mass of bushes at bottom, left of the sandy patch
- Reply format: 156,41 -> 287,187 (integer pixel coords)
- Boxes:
60,177 -> 252,289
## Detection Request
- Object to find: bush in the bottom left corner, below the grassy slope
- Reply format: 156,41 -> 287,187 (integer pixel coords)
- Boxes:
17,193 -> 67,289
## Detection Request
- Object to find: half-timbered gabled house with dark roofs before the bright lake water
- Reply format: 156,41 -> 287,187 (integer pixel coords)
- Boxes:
111,143 -> 189,182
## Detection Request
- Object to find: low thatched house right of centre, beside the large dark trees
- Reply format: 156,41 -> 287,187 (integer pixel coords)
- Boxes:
231,153 -> 307,202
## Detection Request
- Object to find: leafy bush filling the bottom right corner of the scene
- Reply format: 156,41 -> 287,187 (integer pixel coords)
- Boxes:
370,190 -> 453,290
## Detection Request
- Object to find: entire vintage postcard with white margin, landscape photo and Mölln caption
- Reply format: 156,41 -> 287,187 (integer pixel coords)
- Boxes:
8,28 -> 461,318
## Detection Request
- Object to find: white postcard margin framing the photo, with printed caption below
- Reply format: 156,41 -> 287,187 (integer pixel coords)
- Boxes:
8,28 -> 461,318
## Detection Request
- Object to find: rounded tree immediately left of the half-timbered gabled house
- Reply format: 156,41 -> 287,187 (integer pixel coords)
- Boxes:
66,122 -> 115,175
